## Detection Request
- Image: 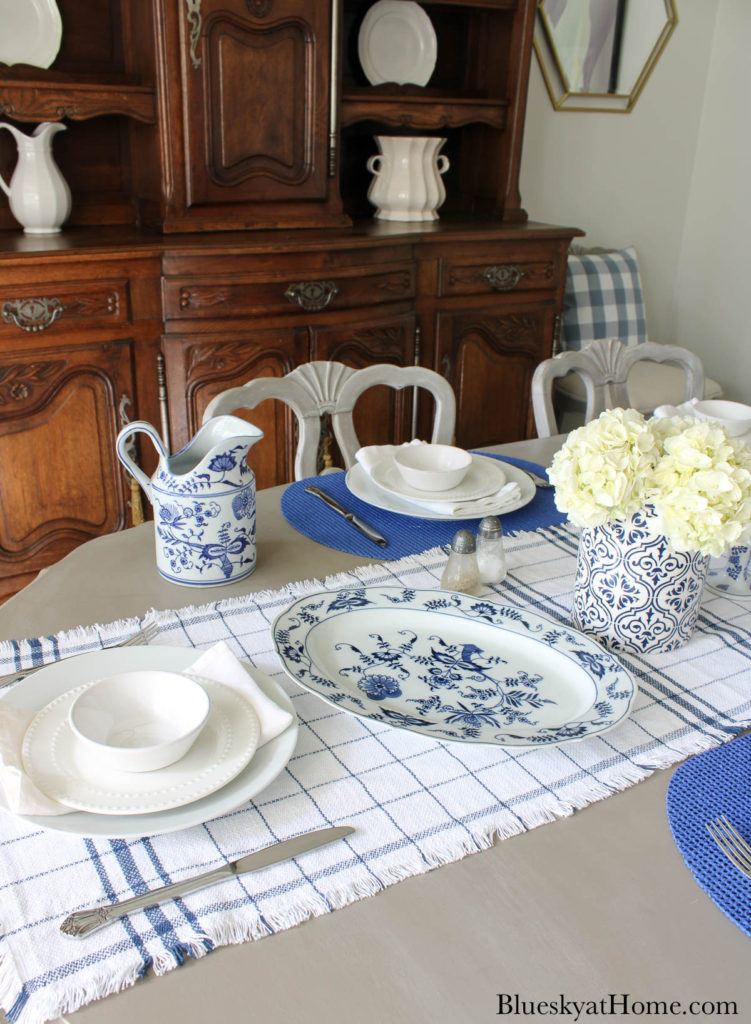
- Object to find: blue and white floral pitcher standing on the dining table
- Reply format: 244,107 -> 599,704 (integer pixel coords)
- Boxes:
117,416 -> 263,587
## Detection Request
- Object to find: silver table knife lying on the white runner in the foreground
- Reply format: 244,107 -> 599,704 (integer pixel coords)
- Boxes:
60,825 -> 354,938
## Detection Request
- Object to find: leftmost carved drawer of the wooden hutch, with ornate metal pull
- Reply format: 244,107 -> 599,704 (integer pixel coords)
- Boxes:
0,281 -> 130,338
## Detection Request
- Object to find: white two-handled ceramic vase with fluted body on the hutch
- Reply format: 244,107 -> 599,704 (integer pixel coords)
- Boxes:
367,135 -> 450,221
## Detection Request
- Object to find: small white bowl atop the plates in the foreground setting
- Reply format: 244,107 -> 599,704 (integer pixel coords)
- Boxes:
69,671 -> 210,772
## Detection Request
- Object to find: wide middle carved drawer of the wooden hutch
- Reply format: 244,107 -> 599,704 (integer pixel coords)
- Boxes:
164,263 -> 416,319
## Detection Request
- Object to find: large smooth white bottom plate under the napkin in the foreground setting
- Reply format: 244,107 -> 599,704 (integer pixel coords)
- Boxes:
7,645 -> 298,839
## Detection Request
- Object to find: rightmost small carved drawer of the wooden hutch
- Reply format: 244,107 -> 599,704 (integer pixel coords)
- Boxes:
439,250 -> 557,296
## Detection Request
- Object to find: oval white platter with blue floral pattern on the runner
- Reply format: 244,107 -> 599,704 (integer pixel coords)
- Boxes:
273,587 -> 636,746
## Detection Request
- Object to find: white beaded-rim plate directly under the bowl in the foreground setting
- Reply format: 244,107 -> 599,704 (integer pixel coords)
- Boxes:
22,679 -> 260,814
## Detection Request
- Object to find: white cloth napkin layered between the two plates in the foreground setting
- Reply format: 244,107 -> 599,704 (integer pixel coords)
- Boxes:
0,640 -> 292,815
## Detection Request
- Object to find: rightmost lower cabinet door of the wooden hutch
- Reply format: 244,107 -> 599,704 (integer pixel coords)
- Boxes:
433,298 -> 555,447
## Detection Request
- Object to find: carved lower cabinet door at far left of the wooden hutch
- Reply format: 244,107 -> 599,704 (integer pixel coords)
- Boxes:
0,339 -> 134,596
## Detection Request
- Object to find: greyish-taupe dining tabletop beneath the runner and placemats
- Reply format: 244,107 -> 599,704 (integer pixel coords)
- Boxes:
0,437 -> 751,1024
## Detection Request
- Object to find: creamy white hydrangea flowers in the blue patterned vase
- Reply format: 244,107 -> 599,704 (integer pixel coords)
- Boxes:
549,409 -> 751,555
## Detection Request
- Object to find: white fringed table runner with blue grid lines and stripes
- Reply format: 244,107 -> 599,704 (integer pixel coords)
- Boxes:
0,524 -> 751,1024
